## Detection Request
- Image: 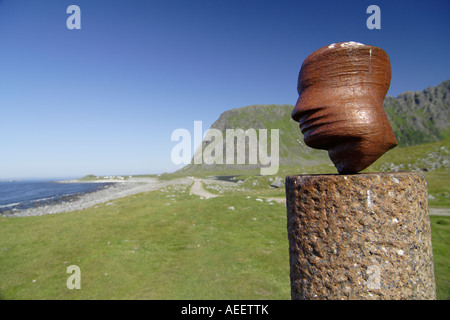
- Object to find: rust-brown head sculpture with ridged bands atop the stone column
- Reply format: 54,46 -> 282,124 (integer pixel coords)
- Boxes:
292,42 -> 397,174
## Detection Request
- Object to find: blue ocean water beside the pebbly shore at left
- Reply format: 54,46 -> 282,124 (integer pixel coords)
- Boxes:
0,180 -> 111,214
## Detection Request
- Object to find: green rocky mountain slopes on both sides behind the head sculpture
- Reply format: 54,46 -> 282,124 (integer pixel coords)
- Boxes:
178,80 -> 450,174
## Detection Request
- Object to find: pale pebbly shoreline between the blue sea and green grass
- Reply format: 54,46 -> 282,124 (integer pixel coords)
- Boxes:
0,178 -> 192,218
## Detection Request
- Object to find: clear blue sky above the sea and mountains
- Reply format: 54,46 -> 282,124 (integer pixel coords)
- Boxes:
0,0 -> 450,179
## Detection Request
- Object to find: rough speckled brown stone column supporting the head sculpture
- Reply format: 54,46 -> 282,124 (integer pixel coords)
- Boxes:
286,172 -> 436,300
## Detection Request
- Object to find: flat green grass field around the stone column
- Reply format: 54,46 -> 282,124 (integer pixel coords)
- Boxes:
0,177 -> 450,300
